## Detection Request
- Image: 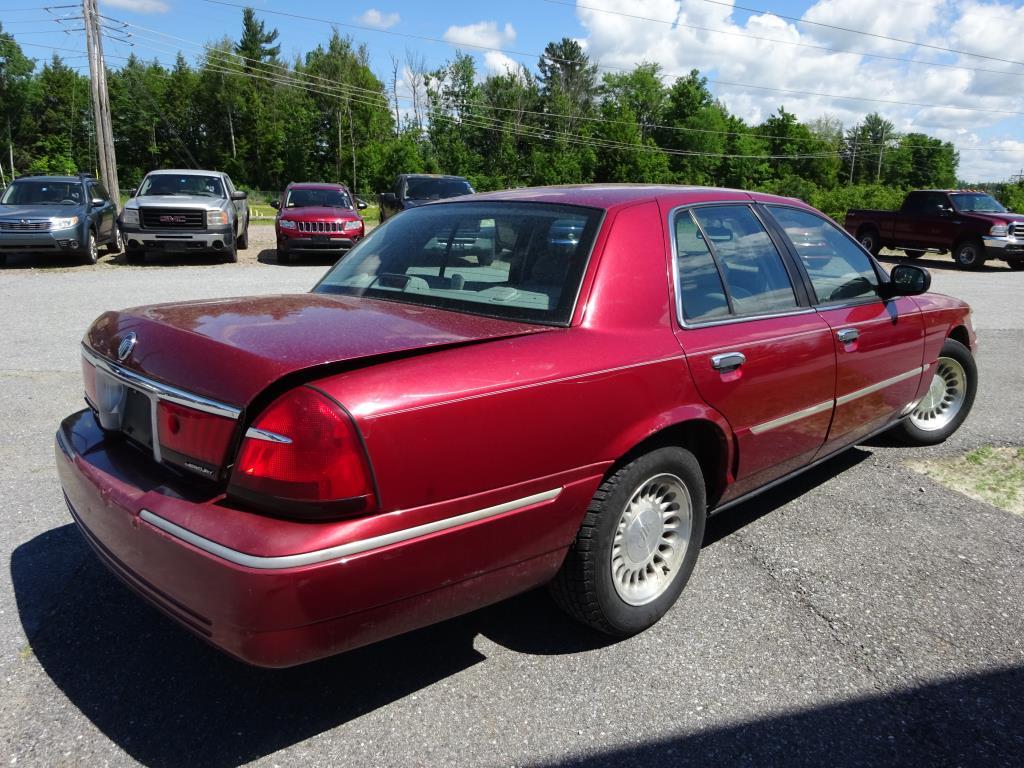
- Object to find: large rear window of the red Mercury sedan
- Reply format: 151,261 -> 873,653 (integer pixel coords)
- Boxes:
313,202 -> 601,325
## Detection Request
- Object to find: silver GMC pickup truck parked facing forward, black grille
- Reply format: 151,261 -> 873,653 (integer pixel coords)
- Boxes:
120,169 -> 249,264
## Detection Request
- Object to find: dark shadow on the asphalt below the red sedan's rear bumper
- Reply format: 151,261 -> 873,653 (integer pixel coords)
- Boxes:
11,524 -> 484,767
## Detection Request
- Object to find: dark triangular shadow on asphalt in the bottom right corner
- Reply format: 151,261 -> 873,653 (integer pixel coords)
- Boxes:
535,667 -> 1024,768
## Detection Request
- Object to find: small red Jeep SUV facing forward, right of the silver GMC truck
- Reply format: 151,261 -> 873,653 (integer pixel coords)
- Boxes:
270,181 -> 367,261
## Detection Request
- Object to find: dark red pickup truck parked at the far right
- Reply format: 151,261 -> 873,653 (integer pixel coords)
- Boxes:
846,189 -> 1024,269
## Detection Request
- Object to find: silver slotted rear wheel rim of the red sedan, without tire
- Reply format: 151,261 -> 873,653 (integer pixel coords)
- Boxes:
610,474 -> 693,605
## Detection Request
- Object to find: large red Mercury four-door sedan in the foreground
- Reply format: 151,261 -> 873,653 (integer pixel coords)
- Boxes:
56,186 -> 976,667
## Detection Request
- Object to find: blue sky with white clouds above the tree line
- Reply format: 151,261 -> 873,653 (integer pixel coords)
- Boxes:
0,0 -> 1024,180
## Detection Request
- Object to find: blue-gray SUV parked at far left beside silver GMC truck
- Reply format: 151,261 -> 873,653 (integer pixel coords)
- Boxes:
0,173 -> 121,264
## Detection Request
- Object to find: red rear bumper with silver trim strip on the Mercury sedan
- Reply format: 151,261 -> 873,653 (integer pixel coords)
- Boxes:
56,411 -> 585,667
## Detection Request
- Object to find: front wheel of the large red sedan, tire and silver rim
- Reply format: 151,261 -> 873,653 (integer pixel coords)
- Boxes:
894,339 -> 978,445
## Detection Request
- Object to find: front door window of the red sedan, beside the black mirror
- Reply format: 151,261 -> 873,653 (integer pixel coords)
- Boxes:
770,206 -> 879,304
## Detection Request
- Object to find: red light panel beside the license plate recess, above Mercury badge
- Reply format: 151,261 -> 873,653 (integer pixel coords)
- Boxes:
157,400 -> 238,477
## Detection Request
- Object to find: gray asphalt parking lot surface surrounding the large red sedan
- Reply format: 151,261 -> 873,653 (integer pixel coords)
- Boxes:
0,234 -> 1024,766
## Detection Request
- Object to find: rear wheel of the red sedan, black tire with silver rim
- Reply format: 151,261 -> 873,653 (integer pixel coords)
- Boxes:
551,447 -> 707,637
